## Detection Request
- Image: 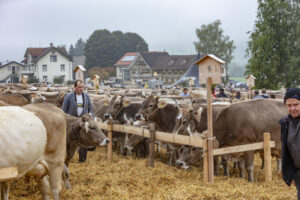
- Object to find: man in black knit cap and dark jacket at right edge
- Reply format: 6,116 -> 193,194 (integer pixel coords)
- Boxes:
279,88 -> 300,200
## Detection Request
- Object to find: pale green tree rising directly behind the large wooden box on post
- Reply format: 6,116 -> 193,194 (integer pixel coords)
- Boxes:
194,20 -> 235,64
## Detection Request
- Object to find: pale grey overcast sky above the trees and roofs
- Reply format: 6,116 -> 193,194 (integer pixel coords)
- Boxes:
0,0 -> 257,63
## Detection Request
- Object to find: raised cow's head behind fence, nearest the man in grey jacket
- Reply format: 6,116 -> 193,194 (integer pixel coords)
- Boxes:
104,95 -> 124,119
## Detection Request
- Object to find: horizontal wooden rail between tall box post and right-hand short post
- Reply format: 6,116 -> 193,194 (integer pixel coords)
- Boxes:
213,141 -> 275,156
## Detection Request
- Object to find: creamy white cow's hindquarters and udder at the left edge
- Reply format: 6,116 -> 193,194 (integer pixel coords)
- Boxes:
0,106 -> 47,200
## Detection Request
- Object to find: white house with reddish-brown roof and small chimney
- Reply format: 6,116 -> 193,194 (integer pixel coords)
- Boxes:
21,43 -> 73,82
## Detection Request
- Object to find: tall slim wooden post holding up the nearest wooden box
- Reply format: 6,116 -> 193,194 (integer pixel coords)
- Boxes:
206,77 -> 214,183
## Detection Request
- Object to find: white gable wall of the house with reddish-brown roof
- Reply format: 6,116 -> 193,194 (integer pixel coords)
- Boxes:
35,51 -> 72,82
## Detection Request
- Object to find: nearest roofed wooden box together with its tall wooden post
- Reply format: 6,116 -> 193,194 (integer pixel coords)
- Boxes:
195,54 -> 225,183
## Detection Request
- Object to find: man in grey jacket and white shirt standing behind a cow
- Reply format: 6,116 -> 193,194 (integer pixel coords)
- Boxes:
62,80 -> 95,162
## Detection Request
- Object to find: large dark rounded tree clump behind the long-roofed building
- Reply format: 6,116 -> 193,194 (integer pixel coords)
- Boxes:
85,29 -> 148,69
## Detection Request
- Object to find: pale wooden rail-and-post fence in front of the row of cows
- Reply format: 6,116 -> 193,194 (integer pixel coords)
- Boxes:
99,120 -> 275,182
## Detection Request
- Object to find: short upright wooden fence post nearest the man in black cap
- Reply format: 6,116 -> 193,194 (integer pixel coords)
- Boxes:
264,133 -> 272,182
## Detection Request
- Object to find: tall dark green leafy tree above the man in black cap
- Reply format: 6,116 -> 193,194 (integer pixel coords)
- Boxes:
246,0 -> 300,89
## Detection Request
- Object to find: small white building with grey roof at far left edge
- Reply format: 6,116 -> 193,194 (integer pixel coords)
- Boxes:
0,61 -> 24,83
